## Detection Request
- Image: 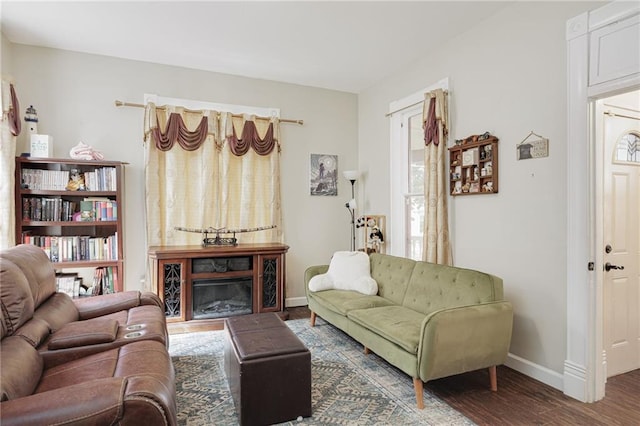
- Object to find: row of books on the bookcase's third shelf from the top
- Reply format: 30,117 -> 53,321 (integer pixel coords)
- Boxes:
22,232 -> 118,262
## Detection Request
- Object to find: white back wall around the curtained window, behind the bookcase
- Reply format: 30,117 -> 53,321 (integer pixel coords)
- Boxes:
12,44 -> 358,299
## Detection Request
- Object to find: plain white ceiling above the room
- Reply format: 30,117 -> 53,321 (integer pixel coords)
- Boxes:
0,0 -> 513,93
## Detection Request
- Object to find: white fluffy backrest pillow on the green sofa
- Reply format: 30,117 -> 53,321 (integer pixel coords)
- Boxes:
309,251 -> 378,296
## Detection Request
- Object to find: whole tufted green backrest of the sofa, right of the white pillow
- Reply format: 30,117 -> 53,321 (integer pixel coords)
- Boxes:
370,253 -> 503,315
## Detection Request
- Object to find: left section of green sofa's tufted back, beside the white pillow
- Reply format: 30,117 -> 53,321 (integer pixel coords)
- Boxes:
370,253 -> 416,305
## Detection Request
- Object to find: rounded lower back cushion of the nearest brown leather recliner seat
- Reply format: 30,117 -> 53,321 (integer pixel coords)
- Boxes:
0,336 -> 43,401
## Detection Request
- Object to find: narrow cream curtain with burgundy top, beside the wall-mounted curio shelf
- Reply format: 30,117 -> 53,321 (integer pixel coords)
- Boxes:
422,89 -> 453,265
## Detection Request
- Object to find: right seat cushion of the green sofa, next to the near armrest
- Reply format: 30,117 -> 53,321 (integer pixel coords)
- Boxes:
347,305 -> 425,355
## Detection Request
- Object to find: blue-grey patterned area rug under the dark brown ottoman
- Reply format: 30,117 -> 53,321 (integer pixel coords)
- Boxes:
169,318 -> 473,426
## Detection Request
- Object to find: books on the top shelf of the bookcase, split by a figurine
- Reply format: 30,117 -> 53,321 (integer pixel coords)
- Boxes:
21,167 -> 117,191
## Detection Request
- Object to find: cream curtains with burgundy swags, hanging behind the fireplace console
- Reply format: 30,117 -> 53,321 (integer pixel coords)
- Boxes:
145,103 -> 282,250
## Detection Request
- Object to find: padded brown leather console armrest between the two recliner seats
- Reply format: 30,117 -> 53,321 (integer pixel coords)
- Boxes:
49,318 -> 118,350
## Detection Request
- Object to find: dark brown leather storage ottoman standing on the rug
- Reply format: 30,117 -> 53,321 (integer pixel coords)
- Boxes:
224,313 -> 311,425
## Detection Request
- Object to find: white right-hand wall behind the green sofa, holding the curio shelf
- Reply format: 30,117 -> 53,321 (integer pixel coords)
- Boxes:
359,2 -> 602,385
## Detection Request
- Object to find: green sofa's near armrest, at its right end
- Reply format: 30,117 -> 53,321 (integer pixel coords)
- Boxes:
418,301 -> 513,382
